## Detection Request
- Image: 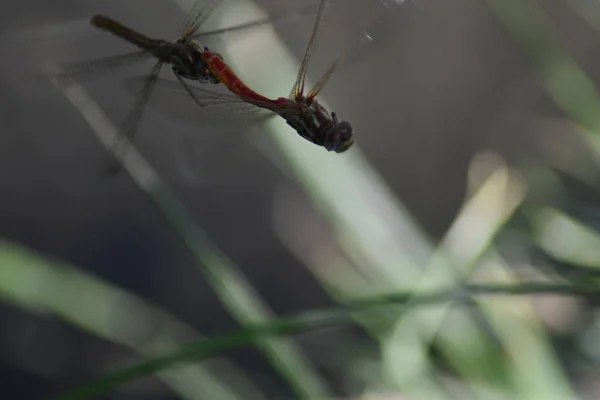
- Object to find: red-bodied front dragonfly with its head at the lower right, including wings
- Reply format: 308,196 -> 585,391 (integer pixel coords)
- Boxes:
128,0 -> 413,153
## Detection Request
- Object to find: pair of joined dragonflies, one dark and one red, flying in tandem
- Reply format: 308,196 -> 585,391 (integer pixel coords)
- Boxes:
56,0 -> 406,170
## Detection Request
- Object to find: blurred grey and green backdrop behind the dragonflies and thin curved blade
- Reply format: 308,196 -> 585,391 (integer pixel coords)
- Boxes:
0,0 -> 600,400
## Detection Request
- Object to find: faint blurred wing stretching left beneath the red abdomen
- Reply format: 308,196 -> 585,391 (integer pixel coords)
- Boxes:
125,76 -> 277,126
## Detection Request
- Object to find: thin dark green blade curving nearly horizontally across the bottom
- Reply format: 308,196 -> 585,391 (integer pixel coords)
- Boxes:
54,272 -> 600,400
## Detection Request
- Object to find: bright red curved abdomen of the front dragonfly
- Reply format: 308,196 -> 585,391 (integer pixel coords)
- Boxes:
202,51 -> 290,111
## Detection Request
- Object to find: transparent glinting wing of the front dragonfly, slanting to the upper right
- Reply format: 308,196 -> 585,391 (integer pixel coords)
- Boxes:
307,0 -> 416,100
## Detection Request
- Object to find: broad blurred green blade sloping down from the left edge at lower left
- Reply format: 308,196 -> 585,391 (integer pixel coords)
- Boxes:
0,241 -> 264,400
